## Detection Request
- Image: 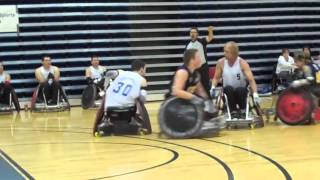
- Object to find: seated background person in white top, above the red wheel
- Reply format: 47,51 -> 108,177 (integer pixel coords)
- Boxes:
276,48 -> 294,74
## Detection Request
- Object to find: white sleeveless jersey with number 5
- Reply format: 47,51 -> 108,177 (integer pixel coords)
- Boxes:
222,57 -> 247,88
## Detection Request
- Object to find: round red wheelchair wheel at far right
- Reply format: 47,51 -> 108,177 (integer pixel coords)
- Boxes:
276,89 -> 315,125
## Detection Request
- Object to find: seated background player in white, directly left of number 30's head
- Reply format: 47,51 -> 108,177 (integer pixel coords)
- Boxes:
86,56 -> 106,90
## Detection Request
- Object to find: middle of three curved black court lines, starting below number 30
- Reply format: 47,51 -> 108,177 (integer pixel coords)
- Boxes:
122,136 -> 234,180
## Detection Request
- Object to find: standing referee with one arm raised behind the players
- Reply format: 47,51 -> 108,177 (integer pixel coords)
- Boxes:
185,26 -> 214,97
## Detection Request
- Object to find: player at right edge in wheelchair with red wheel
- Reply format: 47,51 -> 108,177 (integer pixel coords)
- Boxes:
276,52 -> 320,125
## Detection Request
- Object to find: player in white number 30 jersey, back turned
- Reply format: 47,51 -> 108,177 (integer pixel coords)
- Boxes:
105,60 -> 147,110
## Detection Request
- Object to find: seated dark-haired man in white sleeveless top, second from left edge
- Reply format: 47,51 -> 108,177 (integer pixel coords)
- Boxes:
35,55 -> 61,105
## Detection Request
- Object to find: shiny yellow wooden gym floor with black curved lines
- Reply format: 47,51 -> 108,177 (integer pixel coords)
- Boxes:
0,99 -> 320,180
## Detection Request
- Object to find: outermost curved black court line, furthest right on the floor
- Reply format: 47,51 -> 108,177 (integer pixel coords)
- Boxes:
199,138 -> 292,180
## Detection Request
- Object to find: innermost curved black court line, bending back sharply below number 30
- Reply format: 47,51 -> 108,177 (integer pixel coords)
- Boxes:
1,141 -> 179,180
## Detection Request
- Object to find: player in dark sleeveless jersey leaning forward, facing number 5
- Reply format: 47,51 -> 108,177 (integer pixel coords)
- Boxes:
165,49 -> 216,114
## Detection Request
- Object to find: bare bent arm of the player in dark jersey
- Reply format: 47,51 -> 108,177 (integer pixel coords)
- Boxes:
172,70 -> 193,100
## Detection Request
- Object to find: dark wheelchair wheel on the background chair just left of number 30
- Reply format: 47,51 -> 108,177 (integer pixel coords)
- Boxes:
81,85 -> 97,109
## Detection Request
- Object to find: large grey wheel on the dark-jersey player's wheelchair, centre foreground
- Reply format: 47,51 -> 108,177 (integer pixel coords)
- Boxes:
158,97 -> 203,138
